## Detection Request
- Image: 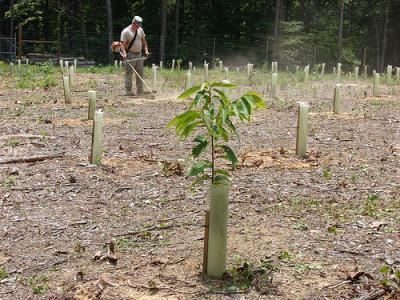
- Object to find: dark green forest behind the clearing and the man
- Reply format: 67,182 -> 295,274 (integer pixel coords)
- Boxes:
0,0 -> 400,72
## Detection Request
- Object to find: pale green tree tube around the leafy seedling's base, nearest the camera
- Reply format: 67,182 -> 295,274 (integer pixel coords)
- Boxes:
207,181 -> 230,278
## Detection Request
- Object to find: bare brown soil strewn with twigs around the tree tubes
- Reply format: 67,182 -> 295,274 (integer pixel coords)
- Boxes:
0,67 -> 400,299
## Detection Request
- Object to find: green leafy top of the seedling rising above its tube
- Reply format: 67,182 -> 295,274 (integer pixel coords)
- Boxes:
167,82 -> 265,184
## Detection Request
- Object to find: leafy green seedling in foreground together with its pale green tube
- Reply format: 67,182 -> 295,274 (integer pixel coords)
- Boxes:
167,81 -> 265,278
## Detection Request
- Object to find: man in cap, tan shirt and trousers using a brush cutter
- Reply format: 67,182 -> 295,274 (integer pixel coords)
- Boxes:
121,16 -> 150,96
